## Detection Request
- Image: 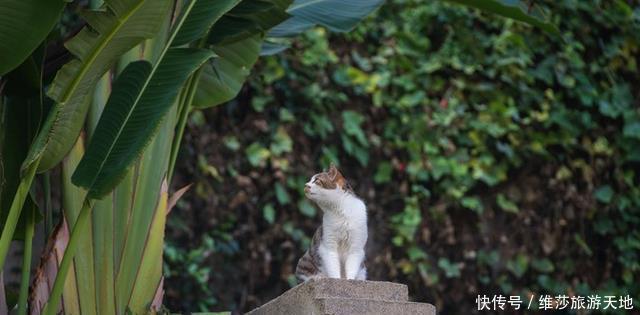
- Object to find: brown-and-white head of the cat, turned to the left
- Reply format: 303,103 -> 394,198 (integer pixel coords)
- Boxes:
304,164 -> 352,203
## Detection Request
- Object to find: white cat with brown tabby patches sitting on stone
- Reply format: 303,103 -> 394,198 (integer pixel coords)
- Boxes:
296,164 -> 367,281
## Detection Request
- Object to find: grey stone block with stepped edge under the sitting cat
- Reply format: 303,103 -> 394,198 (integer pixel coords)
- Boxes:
247,278 -> 436,315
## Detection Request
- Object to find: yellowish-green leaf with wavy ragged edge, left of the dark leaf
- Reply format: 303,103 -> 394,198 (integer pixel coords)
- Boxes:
23,0 -> 173,171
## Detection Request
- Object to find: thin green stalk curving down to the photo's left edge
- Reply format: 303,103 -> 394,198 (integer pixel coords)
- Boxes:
0,159 -> 40,268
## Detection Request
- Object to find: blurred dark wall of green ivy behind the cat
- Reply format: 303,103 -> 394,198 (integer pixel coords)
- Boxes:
165,0 -> 640,314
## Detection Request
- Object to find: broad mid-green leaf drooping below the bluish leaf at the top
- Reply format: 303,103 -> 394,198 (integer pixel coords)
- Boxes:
193,35 -> 262,108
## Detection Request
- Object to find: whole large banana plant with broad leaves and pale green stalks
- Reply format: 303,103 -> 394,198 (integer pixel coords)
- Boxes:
0,0 -> 557,314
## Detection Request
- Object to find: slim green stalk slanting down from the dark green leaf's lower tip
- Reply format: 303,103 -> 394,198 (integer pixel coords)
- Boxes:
42,198 -> 93,315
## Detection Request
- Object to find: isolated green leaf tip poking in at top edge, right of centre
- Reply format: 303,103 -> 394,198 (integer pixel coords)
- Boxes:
446,0 -> 560,35
